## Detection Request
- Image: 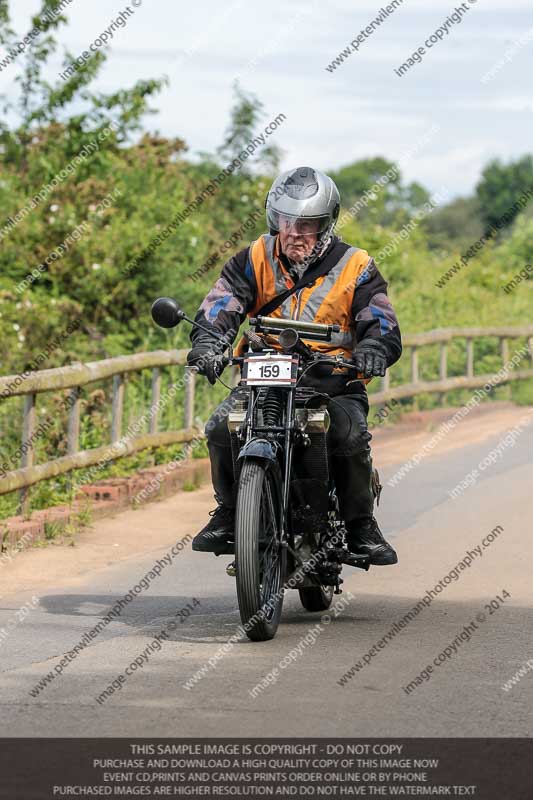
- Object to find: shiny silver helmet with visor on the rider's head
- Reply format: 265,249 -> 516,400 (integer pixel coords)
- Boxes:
265,167 -> 340,263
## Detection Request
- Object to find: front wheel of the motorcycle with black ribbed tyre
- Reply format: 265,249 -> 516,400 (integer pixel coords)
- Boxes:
235,460 -> 286,642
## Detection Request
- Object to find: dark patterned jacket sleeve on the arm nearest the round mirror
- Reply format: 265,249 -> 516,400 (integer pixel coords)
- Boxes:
191,247 -> 257,344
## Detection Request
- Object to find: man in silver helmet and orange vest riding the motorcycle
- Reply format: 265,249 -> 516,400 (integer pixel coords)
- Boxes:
187,167 -> 402,565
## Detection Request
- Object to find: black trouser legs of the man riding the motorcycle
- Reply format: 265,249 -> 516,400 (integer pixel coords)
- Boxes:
205,388 -> 374,523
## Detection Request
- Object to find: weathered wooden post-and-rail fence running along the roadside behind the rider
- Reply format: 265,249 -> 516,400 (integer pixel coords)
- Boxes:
0,325 -> 533,513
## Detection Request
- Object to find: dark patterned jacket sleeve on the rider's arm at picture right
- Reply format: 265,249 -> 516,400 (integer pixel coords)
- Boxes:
352,258 -> 402,367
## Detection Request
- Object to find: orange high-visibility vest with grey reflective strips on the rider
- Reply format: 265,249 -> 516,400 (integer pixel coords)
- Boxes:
239,234 -> 370,358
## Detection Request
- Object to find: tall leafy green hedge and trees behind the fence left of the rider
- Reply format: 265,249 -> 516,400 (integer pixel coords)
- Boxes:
0,0 -> 268,374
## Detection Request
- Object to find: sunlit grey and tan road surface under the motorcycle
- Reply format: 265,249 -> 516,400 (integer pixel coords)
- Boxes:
0,405 -> 533,736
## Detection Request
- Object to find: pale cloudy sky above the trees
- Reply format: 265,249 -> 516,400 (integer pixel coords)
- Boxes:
4,0 -> 533,197
